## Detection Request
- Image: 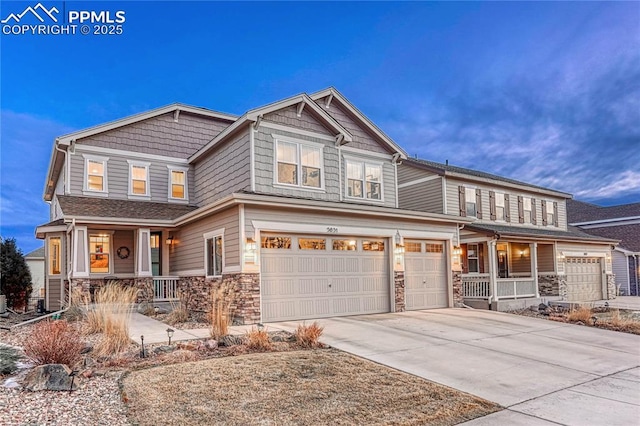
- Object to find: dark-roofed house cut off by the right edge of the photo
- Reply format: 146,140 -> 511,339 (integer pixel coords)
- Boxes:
567,200 -> 640,296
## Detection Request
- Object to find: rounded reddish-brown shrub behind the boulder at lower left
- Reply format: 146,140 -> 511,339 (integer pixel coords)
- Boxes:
24,320 -> 85,368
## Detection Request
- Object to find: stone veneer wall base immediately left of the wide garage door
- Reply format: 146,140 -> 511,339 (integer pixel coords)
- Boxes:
178,273 -> 260,324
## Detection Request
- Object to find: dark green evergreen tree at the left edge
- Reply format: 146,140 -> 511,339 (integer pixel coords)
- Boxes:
0,237 -> 33,309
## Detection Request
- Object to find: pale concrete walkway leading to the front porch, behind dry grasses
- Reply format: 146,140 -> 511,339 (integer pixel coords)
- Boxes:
129,312 -> 252,345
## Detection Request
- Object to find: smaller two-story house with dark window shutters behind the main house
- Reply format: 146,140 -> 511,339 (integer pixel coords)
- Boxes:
398,159 -> 616,309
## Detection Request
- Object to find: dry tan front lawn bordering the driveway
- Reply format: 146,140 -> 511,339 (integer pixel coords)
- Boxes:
123,349 -> 500,425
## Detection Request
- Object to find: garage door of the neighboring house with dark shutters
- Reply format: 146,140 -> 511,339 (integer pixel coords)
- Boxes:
566,257 -> 602,302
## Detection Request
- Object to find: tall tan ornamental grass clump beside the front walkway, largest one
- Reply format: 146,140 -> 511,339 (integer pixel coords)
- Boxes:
86,282 -> 138,355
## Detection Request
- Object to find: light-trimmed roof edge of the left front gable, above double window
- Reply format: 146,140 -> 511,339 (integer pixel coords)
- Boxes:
189,93 -> 353,162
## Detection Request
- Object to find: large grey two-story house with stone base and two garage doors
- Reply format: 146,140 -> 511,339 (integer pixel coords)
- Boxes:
36,88 -> 610,323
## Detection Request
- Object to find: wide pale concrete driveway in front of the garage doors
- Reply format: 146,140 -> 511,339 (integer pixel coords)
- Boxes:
267,309 -> 640,426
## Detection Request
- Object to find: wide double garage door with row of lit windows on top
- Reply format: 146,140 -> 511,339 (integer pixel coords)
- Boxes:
260,234 -> 390,322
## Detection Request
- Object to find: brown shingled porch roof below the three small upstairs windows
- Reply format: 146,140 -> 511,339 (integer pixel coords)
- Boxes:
58,195 -> 198,220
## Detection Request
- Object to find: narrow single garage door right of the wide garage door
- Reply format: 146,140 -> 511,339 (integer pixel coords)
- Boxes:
404,240 -> 449,310
